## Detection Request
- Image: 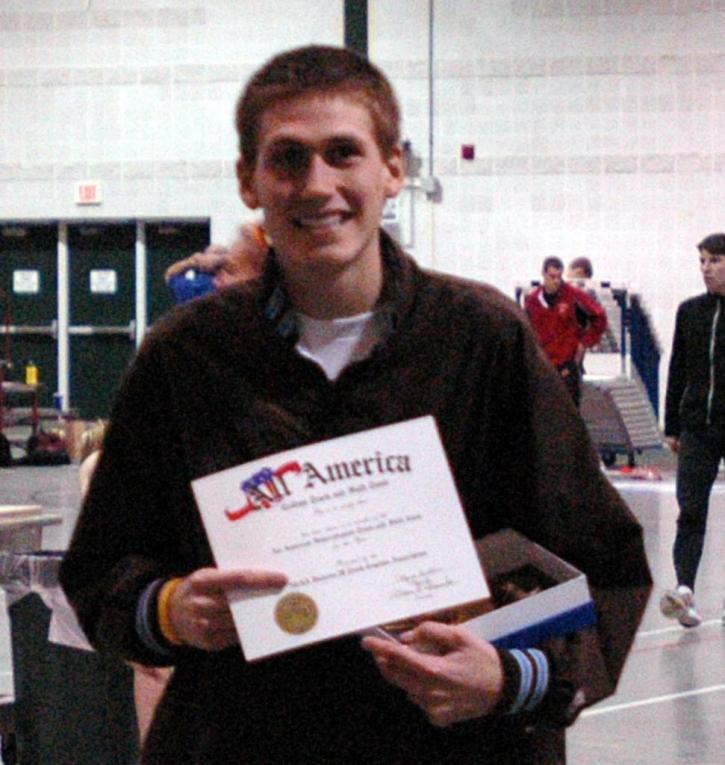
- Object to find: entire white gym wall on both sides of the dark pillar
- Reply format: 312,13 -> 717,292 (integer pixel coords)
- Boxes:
0,0 -> 725,412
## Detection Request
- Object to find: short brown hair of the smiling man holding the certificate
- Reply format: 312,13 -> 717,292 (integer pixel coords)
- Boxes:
235,45 -> 400,171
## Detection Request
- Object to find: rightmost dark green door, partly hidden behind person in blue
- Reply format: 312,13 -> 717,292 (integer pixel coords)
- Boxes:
145,220 -> 209,324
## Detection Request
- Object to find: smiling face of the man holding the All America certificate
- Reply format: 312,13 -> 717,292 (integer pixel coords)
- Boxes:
237,95 -> 403,290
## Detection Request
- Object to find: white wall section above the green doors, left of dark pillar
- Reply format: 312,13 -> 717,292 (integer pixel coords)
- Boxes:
0,0 -> 343,241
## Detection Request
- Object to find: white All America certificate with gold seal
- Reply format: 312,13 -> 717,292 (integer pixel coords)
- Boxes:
192,417 -> 489,661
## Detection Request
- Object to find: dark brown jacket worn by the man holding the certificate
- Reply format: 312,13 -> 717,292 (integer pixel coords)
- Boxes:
61,235 -> 651,765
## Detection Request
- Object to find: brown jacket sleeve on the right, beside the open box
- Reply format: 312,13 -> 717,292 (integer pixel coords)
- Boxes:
484,314 -> 652,727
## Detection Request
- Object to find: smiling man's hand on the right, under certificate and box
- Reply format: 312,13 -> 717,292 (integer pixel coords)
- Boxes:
362,622 -> 504,727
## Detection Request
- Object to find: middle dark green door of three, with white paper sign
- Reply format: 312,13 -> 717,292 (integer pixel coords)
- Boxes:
68,222 -> 136,419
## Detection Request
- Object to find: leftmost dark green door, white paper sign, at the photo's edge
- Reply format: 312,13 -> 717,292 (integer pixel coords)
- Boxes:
0,223 -> 58,406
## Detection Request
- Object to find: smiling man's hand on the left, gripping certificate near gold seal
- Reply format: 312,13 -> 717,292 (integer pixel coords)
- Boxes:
169,568 -> 287,651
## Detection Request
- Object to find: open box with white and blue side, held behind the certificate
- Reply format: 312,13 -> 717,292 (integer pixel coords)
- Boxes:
463,529 -> 597,648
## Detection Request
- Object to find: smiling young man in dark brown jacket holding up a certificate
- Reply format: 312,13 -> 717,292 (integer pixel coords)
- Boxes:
61,46 -> 650,765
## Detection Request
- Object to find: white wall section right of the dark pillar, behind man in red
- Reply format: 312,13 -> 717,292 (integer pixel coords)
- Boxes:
371,0 -> 725,412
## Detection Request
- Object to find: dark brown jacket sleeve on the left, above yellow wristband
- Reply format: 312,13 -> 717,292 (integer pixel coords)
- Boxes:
60,334 -> 203,664
